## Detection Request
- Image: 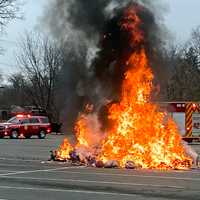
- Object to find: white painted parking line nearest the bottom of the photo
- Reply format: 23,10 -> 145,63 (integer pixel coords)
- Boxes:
0,186 -> 141,200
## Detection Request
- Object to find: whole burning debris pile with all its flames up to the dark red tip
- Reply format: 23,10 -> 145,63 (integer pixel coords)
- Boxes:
52,3 -> 192,169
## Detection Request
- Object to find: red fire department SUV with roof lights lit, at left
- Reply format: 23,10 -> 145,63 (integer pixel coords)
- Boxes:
0,115 -> 51,139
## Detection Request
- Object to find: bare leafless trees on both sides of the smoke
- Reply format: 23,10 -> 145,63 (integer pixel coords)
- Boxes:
0,0 -> 200,122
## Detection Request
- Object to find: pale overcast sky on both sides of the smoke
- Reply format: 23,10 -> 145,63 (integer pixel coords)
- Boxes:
0,0 -> 200,75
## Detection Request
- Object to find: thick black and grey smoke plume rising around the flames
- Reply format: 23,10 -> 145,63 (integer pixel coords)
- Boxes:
44,0 -> 169,132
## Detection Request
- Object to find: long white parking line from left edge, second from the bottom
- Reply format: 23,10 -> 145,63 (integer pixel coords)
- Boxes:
1,175 -> 184,189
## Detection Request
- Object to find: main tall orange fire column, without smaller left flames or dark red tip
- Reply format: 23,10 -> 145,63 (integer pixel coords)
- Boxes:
99,49 -> 191,168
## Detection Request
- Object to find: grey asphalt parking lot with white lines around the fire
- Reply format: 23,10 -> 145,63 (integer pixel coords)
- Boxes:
0,135 -> 200,200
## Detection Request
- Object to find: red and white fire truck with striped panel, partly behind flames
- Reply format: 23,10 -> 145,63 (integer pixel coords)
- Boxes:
160,102 -> 200,142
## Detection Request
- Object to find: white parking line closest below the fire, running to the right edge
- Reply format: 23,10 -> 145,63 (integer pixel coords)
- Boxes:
44,171 -> 200,181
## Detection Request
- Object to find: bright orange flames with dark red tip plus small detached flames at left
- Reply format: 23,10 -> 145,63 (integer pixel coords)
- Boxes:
55,7 -> 191,169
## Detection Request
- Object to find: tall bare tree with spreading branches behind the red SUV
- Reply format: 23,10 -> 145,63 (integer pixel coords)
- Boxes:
17,33 -> 62,120
